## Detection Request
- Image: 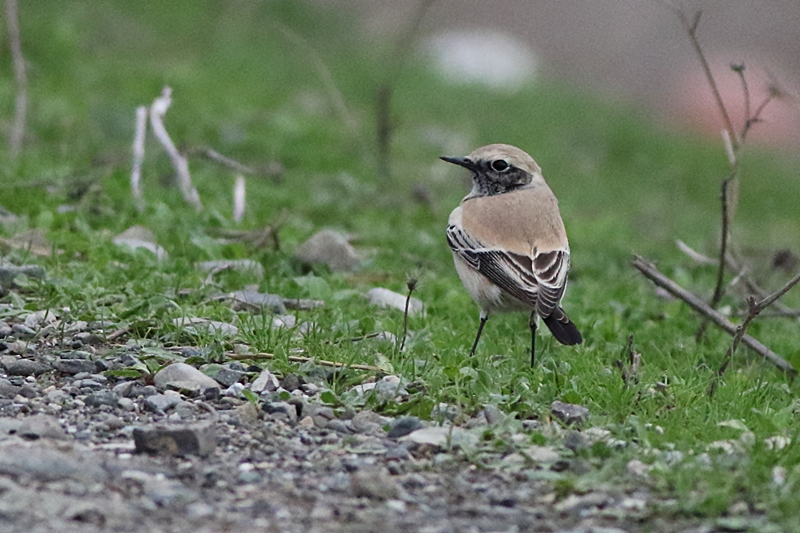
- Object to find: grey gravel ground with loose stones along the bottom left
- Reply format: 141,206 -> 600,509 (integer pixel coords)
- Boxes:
0,317 -> 712,533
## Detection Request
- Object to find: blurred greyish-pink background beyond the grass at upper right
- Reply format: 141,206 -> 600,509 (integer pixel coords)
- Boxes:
326,0 -> 800,149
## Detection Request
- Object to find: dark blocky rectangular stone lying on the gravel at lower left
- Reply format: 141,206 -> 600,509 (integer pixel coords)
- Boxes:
133,423 -> 217,456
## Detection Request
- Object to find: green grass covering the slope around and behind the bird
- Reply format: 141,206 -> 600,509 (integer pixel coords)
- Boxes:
0,0 -> 800,530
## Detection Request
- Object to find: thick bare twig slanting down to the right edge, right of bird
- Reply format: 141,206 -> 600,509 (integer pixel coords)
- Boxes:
632,256 -> 800,377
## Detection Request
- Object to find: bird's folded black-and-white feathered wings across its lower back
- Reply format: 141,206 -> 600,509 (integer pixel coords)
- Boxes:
447,224 -> 569,317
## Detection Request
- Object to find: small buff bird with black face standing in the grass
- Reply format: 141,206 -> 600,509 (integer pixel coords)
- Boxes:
441,144 -> 583,367
